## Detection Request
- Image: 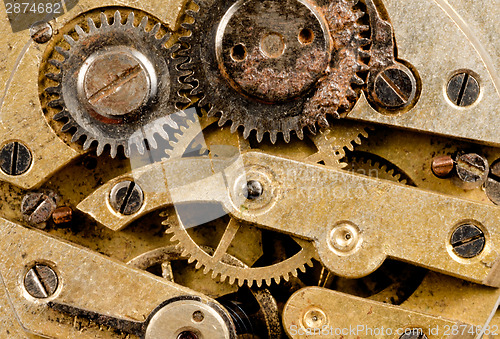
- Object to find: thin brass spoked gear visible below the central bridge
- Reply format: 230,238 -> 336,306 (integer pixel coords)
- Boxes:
165,219 -> 316,287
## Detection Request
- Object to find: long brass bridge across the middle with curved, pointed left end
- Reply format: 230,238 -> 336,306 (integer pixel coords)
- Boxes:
78,153 -> 500,286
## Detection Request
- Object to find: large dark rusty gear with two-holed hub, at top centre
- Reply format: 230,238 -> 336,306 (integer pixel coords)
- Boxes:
183,0 -> 369,143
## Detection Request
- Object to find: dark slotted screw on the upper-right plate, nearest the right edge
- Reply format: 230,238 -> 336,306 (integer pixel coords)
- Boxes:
447,72 -> 480,107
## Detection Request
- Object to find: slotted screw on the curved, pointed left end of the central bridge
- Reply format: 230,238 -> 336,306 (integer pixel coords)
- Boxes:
109,180 -> 144,215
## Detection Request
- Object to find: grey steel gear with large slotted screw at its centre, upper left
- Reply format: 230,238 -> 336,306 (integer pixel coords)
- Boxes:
46,11 -> 190,158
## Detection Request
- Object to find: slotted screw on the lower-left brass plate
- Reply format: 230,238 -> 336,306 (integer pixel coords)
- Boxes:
24,264 -> 59,299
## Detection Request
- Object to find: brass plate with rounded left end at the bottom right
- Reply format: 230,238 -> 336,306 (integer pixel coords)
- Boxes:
283,287 -> 475,339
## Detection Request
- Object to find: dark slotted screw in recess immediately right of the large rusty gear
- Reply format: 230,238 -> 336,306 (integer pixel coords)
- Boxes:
374,65 -> 417,109
